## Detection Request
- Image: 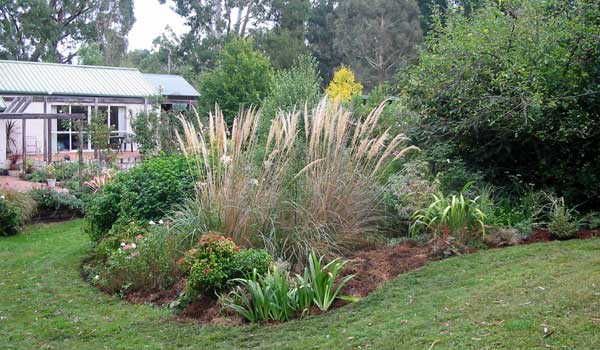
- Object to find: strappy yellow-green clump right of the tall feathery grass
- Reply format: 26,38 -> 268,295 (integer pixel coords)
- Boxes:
411,184 -> 486,238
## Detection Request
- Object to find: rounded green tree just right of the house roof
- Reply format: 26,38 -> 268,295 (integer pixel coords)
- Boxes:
199,38 -> 273,124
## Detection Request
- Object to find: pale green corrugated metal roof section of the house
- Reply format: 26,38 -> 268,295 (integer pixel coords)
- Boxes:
0,60 -> 159,97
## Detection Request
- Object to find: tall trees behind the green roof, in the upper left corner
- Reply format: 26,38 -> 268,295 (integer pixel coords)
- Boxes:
0,0 -> 135,65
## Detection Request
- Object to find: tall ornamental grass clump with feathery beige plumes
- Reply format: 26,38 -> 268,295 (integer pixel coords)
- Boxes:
178,99 -> 414,263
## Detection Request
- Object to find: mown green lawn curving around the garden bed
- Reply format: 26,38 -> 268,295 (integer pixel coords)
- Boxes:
0,221 -> 600,350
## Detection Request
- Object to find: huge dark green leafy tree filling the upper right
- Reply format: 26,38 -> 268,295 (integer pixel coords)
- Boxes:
401,0 -> 600,205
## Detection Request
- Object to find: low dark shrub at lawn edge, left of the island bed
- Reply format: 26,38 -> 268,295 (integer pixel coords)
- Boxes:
29,188 -> 83,216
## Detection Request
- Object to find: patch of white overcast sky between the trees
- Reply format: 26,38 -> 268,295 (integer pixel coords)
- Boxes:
129,0 -> 187,51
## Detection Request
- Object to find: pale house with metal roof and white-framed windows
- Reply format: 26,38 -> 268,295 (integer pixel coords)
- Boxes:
0,60 -> 200,168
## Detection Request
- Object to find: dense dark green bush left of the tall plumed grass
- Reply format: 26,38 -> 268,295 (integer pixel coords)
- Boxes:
86,156 -> 195,241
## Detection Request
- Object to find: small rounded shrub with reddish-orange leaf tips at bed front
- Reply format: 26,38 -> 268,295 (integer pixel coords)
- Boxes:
182,233 -> 271,296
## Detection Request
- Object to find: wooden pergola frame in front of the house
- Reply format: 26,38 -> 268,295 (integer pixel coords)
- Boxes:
0,97 -> 87,184
